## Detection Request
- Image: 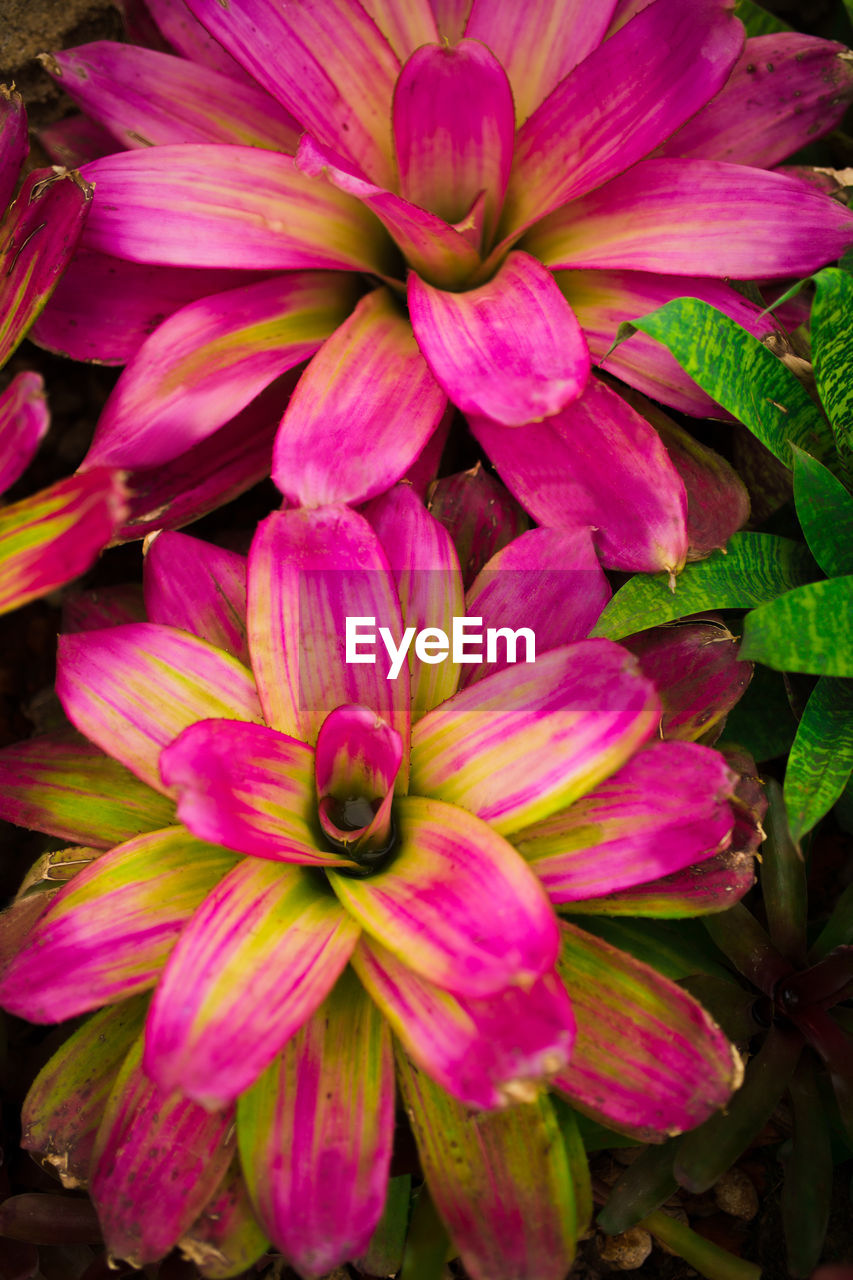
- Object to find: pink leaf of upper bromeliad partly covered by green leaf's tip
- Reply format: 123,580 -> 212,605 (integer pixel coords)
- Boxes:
555,264 -> 775,417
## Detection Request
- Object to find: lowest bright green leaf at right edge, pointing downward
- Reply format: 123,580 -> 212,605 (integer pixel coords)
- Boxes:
785,676 -> 853,840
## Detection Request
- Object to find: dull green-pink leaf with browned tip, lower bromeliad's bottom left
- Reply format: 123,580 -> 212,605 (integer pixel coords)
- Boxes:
20,996 -> 147,1187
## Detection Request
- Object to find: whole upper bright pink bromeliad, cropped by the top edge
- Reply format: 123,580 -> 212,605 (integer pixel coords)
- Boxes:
31,0 -> 853,571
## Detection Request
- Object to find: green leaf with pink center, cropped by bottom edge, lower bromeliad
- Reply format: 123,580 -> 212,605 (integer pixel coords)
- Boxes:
397,1053 -> 578,1280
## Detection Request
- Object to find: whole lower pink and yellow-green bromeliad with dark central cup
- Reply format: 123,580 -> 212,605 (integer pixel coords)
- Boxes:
0,485 -> 758,1280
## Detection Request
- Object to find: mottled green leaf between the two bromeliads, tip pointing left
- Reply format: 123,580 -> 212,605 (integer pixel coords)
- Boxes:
590,534 -> 816,640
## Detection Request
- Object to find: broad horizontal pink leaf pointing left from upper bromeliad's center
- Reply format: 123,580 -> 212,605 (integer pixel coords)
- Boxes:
82,143 -> 386,271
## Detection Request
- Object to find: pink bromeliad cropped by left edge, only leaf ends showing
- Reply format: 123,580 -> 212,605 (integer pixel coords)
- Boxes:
0,84 -> 128,613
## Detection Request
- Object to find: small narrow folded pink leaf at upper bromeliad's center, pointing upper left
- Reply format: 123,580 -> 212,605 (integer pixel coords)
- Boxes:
296,133 -> 480,287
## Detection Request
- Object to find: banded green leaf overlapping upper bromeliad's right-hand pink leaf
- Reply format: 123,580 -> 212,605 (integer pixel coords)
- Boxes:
622,298 -> 834,467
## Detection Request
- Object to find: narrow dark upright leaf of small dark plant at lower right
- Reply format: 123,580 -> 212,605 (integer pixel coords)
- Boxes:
760,778 -> 808,965
